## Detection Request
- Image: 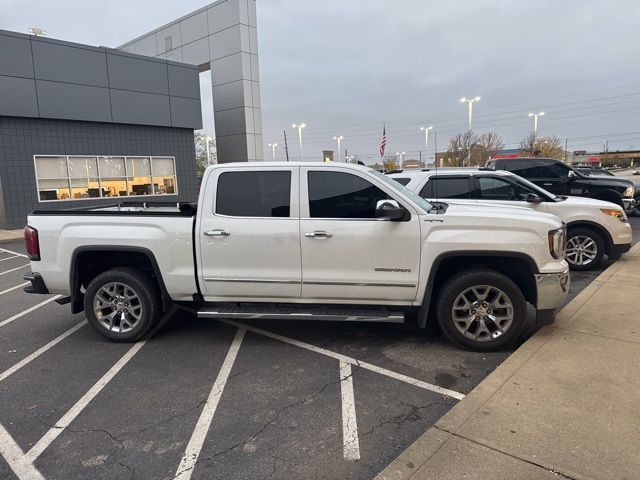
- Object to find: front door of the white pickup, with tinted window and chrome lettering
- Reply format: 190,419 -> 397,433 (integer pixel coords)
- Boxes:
300,166 -> 421,303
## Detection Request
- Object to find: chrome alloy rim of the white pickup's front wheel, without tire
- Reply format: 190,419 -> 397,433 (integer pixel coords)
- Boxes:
451,285 -> 514,342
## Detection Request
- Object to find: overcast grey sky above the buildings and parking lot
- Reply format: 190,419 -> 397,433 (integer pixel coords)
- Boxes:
0,0 -> 640,163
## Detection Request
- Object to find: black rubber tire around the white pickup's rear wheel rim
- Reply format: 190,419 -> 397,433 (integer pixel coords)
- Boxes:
84,267 -> 162,342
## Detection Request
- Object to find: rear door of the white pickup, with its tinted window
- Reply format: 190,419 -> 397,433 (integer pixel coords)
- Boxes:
196,164 -> 302,301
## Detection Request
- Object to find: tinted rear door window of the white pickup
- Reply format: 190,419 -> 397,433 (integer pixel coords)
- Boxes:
216,171 -> 291,217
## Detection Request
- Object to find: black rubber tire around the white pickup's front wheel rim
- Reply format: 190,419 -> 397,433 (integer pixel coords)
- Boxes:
436,269 -> 527,352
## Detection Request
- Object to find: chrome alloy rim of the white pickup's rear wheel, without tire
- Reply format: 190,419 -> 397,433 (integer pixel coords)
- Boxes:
93,282 -> 142,333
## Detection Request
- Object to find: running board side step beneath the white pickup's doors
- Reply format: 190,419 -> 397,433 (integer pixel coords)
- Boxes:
198,304 -> 405,323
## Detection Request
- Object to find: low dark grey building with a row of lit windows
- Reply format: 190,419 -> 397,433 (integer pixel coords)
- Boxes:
0,30 -> 202,229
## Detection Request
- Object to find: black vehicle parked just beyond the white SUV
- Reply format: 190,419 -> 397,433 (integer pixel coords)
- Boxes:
486,157 -> 635,212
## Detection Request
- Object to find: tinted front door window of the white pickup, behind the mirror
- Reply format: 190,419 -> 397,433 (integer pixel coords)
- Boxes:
307,172 -> 390,218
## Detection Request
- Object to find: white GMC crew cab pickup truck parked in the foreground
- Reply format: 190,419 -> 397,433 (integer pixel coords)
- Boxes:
25,162 -> 569,350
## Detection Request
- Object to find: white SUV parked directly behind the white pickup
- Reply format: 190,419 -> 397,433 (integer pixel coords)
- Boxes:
389,168 -> 632,270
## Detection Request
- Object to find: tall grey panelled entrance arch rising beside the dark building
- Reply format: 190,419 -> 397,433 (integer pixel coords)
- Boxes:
118,0 -> 263,163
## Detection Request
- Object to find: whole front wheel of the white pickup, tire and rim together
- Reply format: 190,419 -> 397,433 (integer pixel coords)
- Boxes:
437,269 -> 526,351
